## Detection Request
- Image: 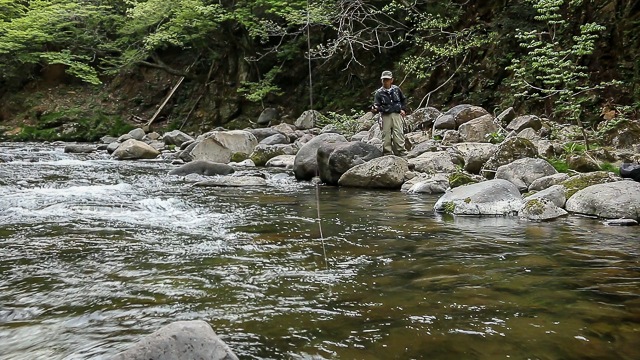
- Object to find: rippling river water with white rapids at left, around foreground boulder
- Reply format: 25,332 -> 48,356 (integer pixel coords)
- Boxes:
0,143 -> 640,360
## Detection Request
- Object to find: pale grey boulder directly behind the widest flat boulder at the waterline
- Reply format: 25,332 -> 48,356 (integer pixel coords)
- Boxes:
495,158 -> 558,192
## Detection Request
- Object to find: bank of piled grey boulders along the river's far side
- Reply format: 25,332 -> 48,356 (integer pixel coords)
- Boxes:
55,105 -> 640,224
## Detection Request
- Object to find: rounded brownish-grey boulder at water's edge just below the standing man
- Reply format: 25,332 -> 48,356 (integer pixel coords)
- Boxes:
338,155 -> 409,189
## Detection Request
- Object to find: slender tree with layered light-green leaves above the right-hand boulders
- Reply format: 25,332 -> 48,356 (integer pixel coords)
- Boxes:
507,0 -> 618,121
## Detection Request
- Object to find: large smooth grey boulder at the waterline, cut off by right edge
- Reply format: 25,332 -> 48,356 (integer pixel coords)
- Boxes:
566,180 -> 640,221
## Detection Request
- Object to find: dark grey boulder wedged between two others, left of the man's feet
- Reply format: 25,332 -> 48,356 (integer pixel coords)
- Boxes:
317,141 -> 382,185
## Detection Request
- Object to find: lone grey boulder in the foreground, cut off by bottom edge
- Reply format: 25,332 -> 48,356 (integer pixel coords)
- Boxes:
112,320 -> 238,360
